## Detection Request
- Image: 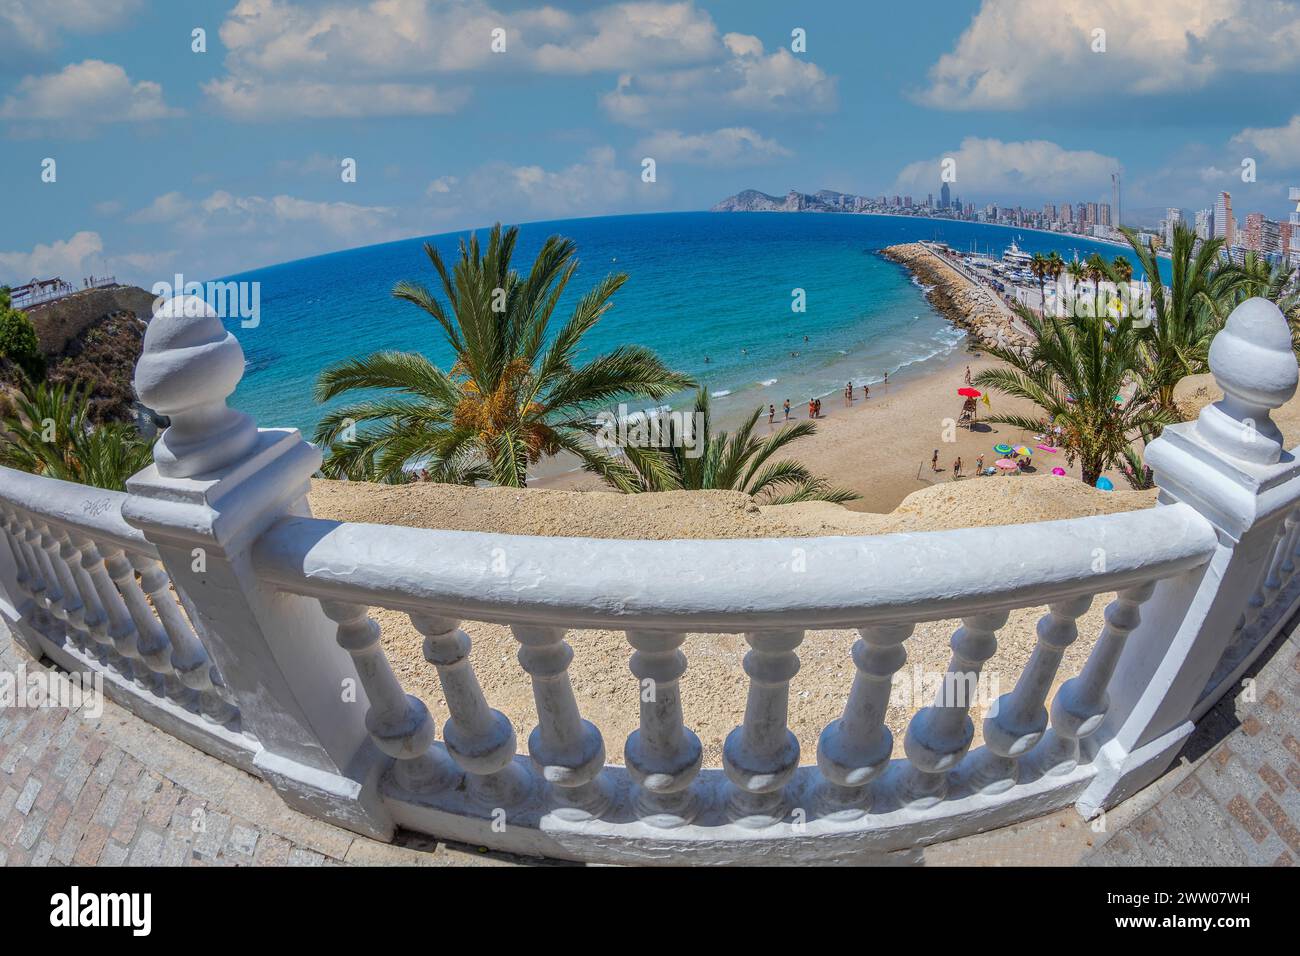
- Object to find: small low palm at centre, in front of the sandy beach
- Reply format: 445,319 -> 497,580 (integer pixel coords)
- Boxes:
611,389 -> 862,505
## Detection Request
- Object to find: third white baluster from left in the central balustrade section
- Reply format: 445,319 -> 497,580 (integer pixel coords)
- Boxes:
511,624 -> 611,822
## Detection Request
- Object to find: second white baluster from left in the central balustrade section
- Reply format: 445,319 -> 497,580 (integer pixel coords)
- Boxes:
411,613 -> 532,809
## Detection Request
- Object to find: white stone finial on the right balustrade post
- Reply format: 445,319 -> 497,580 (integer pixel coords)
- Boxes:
1196,298 -> 1297,464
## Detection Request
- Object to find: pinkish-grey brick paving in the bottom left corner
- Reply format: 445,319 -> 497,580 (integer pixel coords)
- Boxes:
0,628 -> 538,866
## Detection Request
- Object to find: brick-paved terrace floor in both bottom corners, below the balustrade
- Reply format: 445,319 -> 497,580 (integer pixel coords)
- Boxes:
0,621 -> 1300,866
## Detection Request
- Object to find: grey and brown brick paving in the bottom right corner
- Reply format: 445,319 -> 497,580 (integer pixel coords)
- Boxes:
1083,630 -> 1300,866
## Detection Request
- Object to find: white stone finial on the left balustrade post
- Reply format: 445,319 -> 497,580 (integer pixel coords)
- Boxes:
135,295 -> 257,477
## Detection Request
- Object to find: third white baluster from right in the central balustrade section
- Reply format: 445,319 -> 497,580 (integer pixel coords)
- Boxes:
898,611 -> 1009,809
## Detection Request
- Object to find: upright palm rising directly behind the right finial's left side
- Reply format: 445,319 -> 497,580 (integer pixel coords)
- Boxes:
1122,222 -> 1227,414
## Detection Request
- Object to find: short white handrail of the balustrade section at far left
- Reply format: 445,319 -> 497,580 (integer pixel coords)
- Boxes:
0,466 -> 157,558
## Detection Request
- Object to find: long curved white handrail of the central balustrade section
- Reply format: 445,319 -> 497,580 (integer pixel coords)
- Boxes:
254,505 -> 1216,632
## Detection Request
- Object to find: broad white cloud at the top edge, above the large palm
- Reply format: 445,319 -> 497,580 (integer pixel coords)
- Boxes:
204,0 -> 723,120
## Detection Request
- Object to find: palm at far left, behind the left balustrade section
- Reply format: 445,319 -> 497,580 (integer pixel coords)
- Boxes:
0,382 -> 153,492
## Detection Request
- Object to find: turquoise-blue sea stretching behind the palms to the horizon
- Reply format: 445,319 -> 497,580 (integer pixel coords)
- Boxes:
218,212 -> 1164,437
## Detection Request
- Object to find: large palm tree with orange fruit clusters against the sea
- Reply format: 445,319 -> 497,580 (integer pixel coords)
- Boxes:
315,224 -> 693,488
